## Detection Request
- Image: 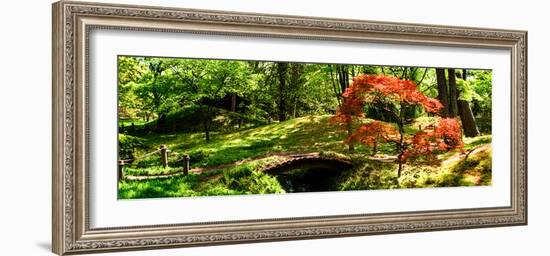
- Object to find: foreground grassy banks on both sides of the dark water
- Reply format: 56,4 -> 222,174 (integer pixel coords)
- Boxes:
118,144 -> 492,199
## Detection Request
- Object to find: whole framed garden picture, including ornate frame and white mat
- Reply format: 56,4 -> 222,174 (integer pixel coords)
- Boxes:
52,1 -> 527,255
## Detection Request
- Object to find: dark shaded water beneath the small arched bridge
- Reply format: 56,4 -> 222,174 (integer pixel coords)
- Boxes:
275,168 -> 341,193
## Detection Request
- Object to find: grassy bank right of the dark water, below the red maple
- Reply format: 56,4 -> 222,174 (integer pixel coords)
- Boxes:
338,135 -> 492,190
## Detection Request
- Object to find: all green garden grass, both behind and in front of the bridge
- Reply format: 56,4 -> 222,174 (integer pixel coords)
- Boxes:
119,116 -> 492,199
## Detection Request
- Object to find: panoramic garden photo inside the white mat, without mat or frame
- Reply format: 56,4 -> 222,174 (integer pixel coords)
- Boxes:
117,56 -> 492,199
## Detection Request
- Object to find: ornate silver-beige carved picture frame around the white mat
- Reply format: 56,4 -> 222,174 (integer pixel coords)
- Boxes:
52,1 -> 527,255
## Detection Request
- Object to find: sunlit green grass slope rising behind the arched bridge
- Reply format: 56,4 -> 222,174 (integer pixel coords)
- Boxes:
134,116 -> 358,170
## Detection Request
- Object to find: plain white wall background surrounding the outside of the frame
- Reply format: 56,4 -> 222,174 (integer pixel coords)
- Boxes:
0,0 -> 550,256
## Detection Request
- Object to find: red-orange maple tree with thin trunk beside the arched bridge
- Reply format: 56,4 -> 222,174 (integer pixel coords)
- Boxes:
331,75 -> 463,177
